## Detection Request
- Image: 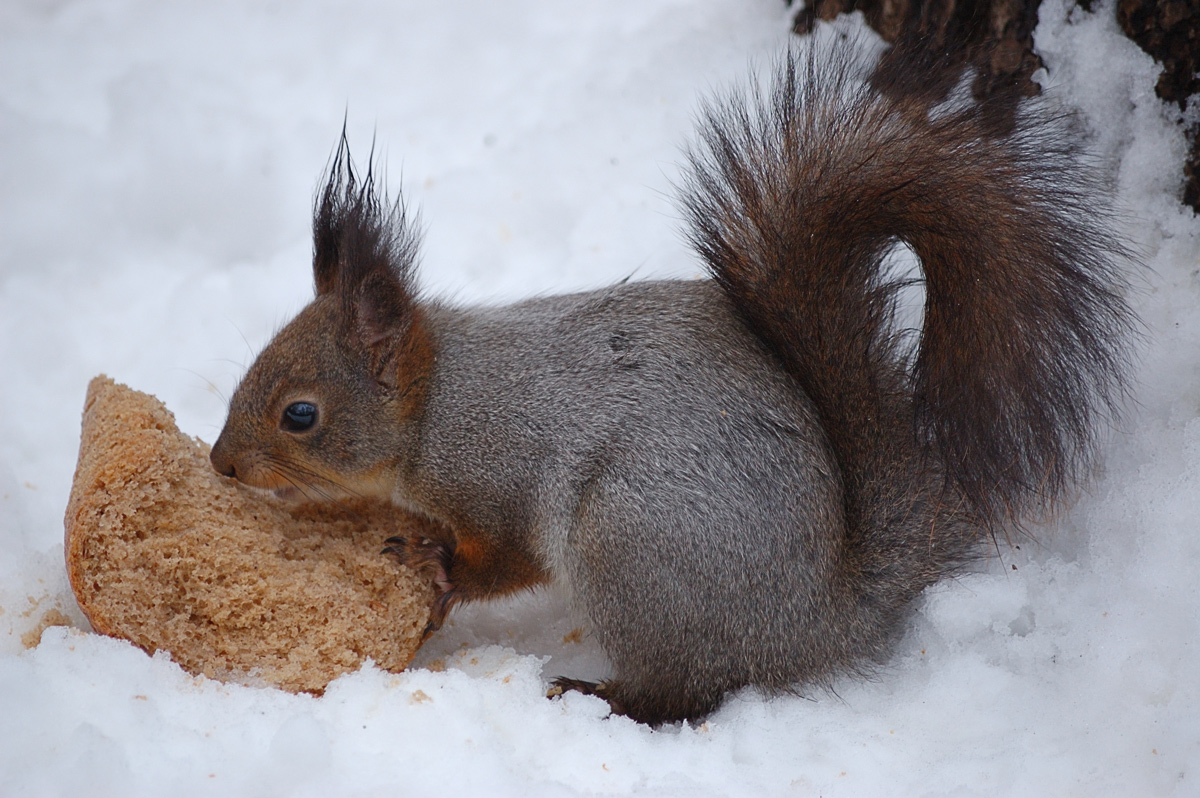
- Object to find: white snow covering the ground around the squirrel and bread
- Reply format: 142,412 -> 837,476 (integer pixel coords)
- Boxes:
0,0 -> 1200,796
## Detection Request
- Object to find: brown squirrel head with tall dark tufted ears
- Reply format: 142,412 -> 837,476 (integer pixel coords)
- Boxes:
210,133 -> 433,500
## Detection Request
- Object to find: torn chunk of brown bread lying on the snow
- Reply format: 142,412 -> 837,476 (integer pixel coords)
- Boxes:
66,377 -> 434,692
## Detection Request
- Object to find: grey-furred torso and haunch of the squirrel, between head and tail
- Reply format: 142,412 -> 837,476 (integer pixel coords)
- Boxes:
396,281 -> 842,710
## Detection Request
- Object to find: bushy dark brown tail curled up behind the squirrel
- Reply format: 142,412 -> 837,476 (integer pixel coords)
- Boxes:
683,47 -> 1136,548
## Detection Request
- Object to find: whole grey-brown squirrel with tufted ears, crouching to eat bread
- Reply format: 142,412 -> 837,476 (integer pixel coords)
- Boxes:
211,46 -> 1139,725
